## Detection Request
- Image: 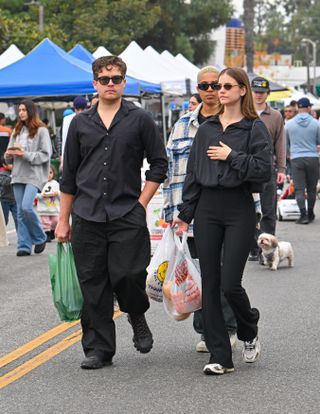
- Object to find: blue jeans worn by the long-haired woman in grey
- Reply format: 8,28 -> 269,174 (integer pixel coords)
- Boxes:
13,184 -> 47,253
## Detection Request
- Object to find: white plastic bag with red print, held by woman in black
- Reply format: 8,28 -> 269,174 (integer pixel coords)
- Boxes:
163,233 -> 202,320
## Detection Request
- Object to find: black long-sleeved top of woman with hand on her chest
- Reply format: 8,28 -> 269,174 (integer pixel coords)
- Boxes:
178,116 -> 272,223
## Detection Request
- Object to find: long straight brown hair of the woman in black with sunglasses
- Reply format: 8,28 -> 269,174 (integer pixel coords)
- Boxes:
217,68 -> 259,119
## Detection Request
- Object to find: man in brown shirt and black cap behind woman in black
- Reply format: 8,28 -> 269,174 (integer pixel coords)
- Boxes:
249,76 -> 286,260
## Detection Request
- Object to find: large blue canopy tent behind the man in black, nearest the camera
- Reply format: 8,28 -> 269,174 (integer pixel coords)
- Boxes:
0,39 -> 160,100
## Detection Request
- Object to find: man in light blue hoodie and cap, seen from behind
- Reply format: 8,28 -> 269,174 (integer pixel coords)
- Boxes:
285,97 -> 320,224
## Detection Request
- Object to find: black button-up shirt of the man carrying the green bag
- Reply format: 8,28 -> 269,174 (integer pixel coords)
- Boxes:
60,99 -> 168,222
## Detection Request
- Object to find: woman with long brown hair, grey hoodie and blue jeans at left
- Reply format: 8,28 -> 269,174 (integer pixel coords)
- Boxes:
5,99 -> 52,256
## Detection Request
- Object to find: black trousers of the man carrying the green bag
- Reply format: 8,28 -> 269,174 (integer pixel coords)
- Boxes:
71,203 -> 150,358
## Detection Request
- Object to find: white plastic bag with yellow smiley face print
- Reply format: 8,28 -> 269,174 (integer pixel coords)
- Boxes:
146,226 -> 177,302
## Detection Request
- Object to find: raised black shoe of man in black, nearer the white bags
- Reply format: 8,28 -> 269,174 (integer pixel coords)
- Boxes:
128,313 -> 153,354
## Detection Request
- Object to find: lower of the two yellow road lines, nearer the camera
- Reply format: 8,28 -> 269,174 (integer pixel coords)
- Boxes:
0,310 -> 122,389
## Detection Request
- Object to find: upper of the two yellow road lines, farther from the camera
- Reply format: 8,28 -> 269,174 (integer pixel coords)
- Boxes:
0,321 -> 79,368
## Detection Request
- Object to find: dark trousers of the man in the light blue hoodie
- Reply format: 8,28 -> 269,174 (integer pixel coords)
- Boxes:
291,157 -> 319,211
